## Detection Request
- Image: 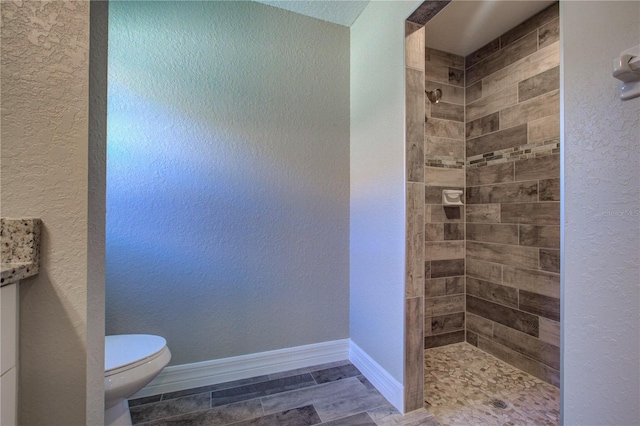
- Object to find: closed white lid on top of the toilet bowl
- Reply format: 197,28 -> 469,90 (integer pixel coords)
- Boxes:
104,334 -> 167,371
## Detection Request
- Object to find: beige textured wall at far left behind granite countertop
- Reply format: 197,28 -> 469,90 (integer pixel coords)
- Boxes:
1,1 -> 104,425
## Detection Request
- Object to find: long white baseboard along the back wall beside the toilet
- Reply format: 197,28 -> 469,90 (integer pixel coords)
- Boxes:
131,339 -> 350,399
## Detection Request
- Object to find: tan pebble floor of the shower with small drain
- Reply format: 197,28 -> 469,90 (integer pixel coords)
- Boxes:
424,343 -> 560,426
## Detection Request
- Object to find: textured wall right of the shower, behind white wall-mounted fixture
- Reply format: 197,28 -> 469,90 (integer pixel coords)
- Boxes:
560,1 -> 640,425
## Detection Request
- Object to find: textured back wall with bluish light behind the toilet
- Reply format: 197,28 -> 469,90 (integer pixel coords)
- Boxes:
107,1 -> 349,365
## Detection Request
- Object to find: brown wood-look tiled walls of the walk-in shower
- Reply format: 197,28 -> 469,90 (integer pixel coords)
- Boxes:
404,1 -> 561,409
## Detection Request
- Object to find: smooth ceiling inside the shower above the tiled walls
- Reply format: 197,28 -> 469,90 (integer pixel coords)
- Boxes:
425,0 -> 555,56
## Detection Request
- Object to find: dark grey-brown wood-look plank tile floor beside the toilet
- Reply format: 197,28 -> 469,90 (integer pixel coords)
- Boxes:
129,361 -> 439,426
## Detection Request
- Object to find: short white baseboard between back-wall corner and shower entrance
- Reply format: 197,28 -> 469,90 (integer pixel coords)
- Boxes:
349,341 -> 404,413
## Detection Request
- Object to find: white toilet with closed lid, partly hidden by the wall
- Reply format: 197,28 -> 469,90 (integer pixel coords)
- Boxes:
104,334 -> 171,426
